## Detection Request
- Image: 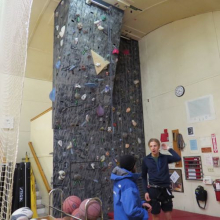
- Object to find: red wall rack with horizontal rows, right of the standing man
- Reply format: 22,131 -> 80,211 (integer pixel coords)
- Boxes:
183,156 -> 203,181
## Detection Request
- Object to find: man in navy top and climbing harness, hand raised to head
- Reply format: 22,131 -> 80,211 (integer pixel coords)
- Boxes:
142,138 -> 181,220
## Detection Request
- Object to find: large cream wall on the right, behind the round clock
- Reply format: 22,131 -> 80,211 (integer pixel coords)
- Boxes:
139,12 -> 220,216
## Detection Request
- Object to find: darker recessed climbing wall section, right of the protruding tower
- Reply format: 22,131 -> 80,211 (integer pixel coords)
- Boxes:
113,38 -> 145,175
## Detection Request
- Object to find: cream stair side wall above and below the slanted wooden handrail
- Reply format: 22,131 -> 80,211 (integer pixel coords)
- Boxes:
30,111 -> 53,213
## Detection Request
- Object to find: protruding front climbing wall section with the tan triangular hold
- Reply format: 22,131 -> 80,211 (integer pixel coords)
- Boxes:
50,0 -> 123,217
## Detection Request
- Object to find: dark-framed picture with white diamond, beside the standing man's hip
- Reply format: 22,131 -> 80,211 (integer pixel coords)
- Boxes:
169,169 -> 184,192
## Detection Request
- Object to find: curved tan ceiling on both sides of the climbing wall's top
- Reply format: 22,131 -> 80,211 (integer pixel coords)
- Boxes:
26,0 -> 220,81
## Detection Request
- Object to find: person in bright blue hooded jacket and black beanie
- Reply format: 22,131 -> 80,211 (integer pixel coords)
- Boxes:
111,155 -> 151,220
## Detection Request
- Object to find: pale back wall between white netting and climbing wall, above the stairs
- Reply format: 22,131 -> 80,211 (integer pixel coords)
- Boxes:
17,78 -> 52,162
